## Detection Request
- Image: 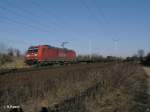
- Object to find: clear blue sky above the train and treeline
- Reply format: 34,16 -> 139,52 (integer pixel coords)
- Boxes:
0,0 -> 150,56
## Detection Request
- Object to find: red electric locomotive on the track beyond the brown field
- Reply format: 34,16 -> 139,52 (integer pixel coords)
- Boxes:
25,45 -> 76,65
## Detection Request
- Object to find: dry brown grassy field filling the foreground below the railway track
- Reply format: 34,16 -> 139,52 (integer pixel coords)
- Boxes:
0,62 -> 149,112
